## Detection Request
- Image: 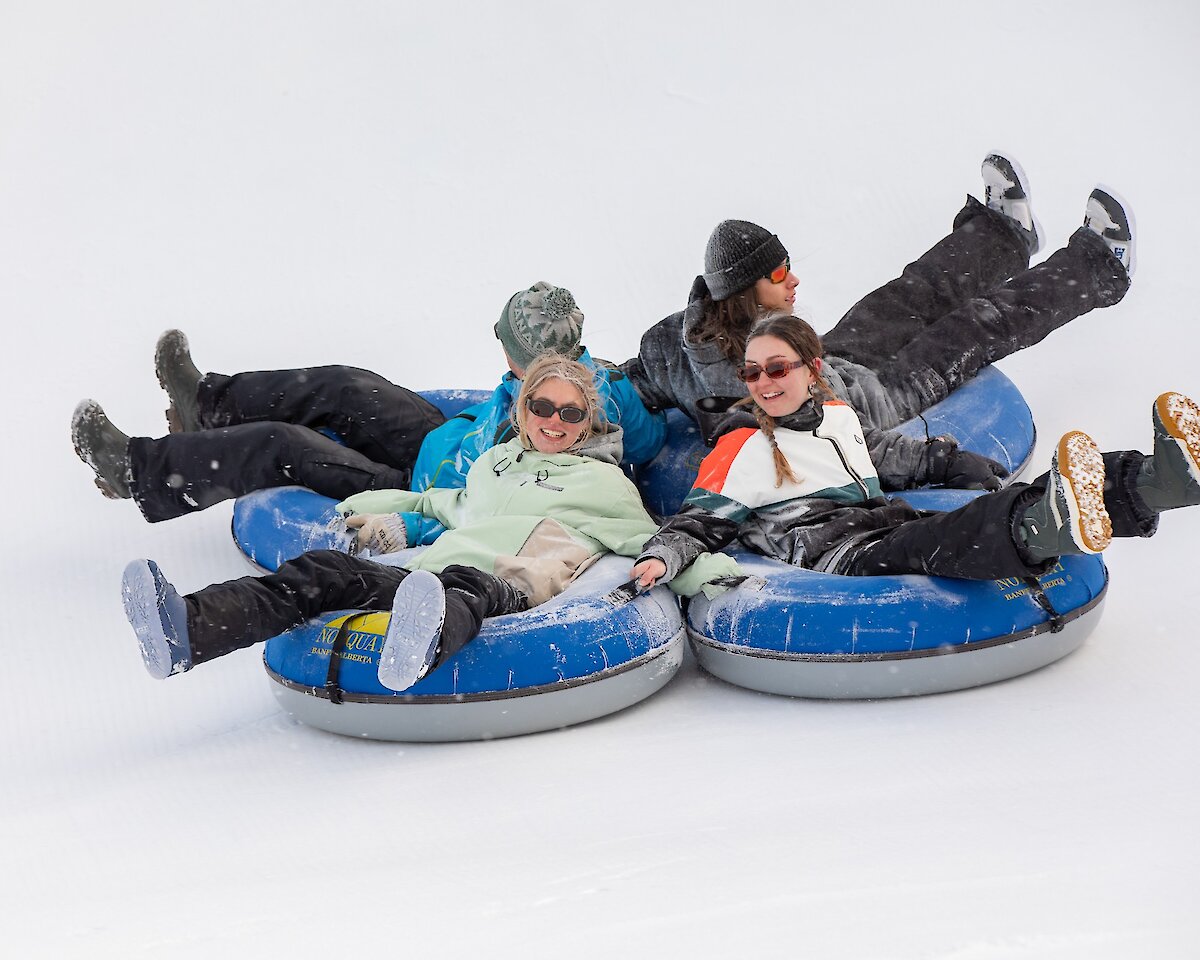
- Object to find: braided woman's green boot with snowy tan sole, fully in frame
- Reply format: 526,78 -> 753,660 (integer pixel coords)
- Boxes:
1016,430 -> 1112,560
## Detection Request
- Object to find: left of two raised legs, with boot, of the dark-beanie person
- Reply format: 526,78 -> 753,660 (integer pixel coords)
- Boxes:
822,155 -> 1039,370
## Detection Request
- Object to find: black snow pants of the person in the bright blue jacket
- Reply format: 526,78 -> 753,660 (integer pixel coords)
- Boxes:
128,366 -> 445,522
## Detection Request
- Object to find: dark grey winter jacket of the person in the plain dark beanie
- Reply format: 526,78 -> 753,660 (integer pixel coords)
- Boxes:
620,277 -> 900,430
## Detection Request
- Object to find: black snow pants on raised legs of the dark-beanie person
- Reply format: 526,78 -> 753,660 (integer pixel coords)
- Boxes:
822,197 -> 1129,420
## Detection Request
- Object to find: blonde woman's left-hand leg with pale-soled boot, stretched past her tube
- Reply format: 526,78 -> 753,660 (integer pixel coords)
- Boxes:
121,550 -> 408,679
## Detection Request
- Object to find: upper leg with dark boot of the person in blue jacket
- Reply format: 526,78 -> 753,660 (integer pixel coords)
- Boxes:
155,330 -> 445,467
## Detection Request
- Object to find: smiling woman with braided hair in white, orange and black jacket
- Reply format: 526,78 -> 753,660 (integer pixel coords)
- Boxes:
634,313 -> 1200,587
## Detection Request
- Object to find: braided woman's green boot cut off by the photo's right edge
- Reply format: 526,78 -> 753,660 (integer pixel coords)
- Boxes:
1138,394 -> 1200,512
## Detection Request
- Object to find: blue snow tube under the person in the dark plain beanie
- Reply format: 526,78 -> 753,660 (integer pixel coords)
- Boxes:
637,367 -> 1037,516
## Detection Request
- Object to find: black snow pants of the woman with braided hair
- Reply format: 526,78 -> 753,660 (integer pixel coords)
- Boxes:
834,450 -> 1158,580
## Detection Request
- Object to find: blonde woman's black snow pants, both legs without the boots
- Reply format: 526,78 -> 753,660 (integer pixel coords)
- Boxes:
184,550 -> 524,665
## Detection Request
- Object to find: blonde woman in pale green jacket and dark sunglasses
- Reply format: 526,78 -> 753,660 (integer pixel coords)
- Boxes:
122,354 -> 737,690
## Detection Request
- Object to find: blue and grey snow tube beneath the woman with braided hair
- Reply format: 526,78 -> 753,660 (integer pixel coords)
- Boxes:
688,554 -> 1108,700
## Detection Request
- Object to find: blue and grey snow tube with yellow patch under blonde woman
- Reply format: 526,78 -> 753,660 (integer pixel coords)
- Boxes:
263,554 -> 685,742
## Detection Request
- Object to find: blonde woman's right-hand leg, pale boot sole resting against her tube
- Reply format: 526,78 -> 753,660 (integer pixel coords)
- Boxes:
379,564 -> 528,690
